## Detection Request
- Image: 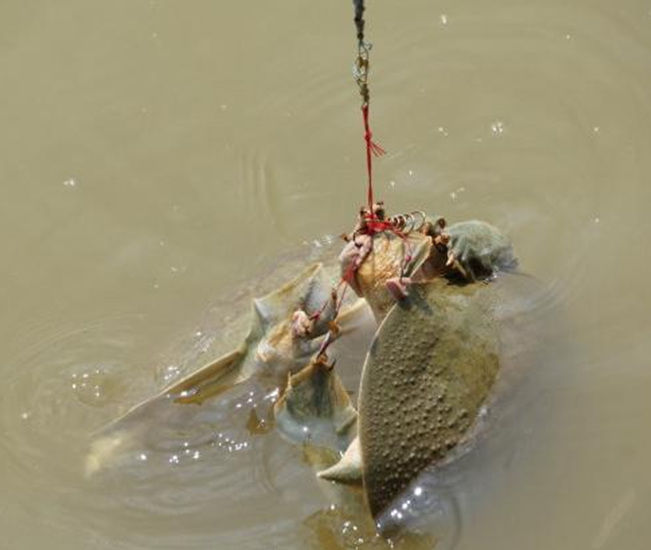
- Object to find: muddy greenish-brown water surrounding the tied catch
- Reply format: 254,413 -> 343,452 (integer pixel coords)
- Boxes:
0,0 -> 651,550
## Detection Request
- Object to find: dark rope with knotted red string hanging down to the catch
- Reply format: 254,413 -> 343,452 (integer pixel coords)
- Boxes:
353,0 -> 386,219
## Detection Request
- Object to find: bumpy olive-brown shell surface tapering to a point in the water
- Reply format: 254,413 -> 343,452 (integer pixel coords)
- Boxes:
359,279 -> 502,517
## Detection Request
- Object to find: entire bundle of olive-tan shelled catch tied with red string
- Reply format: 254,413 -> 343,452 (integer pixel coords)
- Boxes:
88,199 -> 514,540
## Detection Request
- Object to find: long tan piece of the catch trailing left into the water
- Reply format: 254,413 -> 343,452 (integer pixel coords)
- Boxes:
86,264 -> 368,474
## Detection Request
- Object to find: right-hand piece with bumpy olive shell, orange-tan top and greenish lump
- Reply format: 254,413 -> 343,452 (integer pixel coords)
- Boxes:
328,211 -> 517,528
